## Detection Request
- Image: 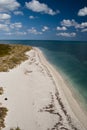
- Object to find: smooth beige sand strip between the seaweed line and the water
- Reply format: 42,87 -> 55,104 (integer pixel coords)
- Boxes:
36,48 -> 87,130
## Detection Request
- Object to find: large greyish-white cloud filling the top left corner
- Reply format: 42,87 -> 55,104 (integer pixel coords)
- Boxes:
0,0 -> 20,11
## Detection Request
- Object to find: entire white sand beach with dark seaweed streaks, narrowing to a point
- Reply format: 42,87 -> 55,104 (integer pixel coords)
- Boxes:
0,48 -> 87,130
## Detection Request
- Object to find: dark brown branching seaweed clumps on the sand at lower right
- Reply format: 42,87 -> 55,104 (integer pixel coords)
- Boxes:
39,93 -> 78,130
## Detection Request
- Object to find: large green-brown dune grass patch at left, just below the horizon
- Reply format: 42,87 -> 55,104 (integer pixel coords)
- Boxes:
0,44 -> 32,72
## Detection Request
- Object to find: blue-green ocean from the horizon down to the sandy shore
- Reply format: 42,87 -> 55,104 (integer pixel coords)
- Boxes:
0,40 -> 87,110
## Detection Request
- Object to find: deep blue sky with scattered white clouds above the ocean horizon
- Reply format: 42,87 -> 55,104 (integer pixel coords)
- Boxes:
0,0 -> 87,41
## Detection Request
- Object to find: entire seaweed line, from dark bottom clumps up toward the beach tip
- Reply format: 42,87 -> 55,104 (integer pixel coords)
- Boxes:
38,49 -> 79,130
